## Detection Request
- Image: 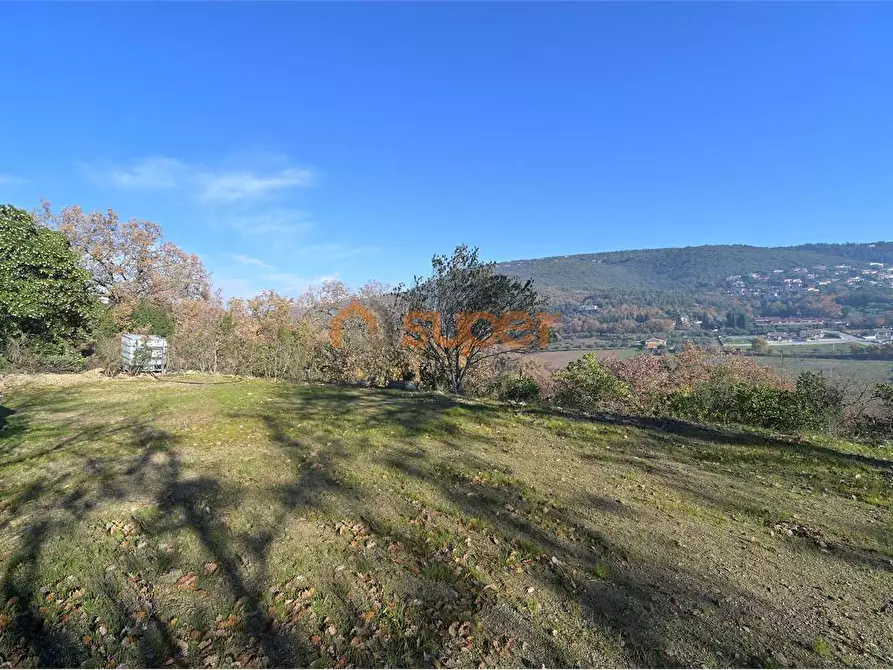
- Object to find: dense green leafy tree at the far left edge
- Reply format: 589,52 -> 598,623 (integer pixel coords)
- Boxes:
0,205 -> 97,342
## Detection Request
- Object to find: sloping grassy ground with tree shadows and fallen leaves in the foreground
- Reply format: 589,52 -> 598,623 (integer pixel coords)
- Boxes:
0,375 -> 893,667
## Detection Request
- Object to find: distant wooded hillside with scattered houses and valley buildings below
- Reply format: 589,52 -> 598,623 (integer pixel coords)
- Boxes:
498,247 -> 893,357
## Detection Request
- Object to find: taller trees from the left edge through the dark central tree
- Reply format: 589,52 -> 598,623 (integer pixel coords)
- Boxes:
0,202 -> 543,393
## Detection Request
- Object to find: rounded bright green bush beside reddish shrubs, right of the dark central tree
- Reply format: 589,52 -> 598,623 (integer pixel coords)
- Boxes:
554,354 -> 630,412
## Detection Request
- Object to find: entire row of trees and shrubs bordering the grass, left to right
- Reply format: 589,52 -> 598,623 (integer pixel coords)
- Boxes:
0,203 -> 893,440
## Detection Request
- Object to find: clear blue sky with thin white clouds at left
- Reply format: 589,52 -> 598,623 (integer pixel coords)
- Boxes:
0,3 -> 893,295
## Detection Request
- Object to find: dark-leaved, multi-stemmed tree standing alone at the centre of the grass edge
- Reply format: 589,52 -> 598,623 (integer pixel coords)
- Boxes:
397,245 -> 548,393
